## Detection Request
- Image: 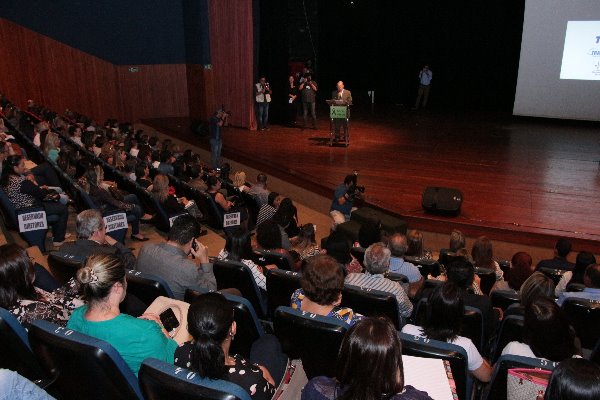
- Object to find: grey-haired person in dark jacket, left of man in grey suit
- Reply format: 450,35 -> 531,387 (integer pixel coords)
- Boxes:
60,209 -> 135,269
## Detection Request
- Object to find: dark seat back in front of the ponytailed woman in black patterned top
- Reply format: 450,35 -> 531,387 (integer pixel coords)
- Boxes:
184,286 -> 265,358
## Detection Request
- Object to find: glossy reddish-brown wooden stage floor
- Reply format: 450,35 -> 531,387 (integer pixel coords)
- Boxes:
142,107 -> 600,254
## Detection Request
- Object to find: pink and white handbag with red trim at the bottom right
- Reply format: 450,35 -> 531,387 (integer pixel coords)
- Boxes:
506,368 -> 552,400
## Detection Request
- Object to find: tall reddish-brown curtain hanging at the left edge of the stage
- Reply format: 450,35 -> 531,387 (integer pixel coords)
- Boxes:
209,0 -> 256,129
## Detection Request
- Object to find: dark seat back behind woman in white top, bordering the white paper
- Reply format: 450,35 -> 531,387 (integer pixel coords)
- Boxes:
399,333 -> 472,399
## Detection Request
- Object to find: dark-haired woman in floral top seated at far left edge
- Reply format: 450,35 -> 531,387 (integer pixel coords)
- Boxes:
0,244 -> 83,328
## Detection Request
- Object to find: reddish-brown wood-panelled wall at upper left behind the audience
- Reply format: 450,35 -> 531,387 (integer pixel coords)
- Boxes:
0,19 -> 189,121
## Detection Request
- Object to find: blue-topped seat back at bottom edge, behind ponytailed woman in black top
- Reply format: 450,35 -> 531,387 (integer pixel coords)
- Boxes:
139,358 -> 251,400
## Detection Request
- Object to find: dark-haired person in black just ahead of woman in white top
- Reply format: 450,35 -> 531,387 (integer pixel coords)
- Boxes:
448,259 -> 494,337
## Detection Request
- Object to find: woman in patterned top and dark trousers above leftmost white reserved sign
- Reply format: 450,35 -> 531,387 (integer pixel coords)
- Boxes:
0,155 -> 70,247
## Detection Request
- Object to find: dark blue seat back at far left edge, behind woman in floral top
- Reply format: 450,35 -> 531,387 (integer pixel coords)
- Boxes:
0,308 -> 45,381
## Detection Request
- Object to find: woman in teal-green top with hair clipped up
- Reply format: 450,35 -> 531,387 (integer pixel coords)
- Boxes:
67,254 -> 177,376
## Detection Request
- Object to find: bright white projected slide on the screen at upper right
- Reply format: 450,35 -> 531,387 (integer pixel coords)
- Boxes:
560,21 -> 600,81
